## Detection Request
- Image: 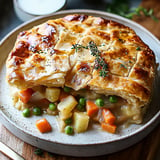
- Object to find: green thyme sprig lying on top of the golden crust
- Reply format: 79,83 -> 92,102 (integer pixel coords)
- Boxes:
71,41 -> 109,77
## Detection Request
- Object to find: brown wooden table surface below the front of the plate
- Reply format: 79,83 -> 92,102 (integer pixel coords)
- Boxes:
0,124 -> 160,160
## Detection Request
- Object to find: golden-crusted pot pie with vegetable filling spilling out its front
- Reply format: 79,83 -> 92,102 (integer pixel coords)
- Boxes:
6,14 -> 156,134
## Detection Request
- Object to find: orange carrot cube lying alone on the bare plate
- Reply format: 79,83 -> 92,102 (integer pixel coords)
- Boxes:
36,118 -> 52,133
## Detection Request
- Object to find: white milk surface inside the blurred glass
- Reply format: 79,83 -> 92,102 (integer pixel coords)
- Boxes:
18,0 -> 65,15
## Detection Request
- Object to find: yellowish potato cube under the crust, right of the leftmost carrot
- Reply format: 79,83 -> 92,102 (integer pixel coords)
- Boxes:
45,88 -> 60,102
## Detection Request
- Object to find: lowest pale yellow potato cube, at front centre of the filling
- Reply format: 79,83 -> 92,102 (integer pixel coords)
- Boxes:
73,112 -> 89,133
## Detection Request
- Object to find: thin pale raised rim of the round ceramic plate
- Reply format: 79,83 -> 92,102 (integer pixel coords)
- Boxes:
0,9 -> 160,146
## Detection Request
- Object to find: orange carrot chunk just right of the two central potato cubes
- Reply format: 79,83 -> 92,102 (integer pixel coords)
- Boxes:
86,101 -> 99,117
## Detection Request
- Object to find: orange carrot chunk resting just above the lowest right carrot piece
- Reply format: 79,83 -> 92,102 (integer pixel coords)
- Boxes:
102,108 -> 116,124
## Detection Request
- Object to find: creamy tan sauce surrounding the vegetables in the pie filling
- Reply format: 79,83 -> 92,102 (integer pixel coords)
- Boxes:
11,86 -> 142,132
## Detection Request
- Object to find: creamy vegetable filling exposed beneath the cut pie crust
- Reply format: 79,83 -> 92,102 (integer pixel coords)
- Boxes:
12,86 -> 144,133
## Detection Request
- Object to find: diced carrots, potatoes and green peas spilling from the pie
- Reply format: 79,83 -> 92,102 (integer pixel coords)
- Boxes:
18,86 -> 118,135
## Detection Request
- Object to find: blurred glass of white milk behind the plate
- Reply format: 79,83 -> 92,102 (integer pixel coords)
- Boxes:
13,0 -> 66,21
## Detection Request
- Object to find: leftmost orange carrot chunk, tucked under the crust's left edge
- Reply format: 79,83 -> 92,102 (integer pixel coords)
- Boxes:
19,88 -> 34,103
